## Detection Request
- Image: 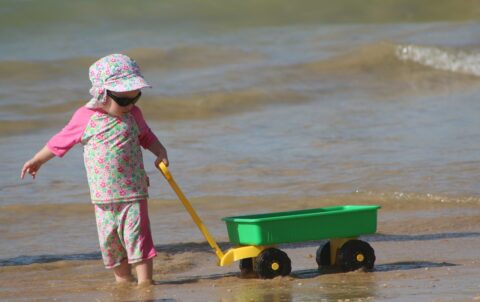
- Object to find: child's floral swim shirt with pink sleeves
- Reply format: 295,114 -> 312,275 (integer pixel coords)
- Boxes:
47,106 -> 157,204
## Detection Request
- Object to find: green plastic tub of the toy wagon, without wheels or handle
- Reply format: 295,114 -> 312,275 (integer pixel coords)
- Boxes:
223,205 -> 380,245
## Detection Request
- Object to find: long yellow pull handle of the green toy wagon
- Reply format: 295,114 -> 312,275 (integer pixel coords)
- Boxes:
158,162 -> 224,261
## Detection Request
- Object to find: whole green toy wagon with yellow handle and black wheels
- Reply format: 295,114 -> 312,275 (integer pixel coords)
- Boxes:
159,163 -> 380,279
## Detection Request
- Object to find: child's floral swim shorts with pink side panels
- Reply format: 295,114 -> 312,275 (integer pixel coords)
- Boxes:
95,200 -> 157,268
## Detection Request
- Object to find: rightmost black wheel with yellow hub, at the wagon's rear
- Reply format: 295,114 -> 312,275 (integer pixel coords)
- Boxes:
337,239 -> 375,272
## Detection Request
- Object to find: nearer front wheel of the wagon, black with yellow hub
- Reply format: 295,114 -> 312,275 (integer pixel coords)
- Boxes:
255,248 -> 292,279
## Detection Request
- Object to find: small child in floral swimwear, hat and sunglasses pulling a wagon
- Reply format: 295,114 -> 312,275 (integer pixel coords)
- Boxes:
21,54 -> 168,284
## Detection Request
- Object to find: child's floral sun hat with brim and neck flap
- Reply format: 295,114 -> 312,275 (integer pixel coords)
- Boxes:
85,54 -> 152,109
